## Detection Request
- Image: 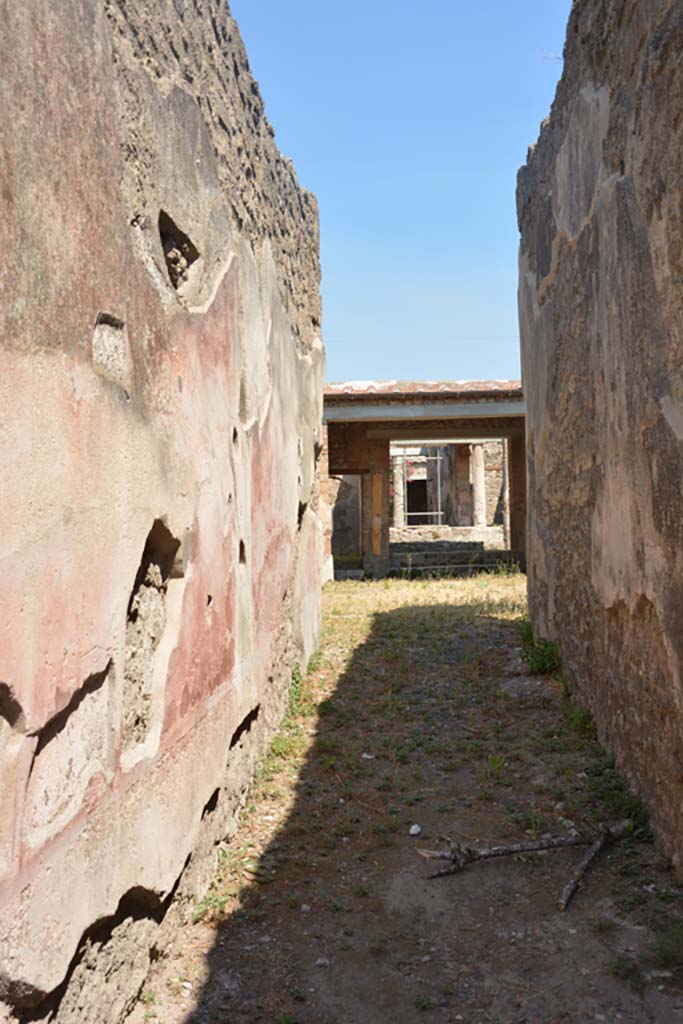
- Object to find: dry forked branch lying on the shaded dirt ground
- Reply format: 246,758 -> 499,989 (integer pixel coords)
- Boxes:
418,821 -> 631,910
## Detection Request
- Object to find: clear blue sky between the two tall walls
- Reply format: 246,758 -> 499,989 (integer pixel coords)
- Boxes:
230,0 -> 570,380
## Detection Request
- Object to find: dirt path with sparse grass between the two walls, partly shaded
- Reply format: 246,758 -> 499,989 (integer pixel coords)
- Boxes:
131,575 -> 683,1024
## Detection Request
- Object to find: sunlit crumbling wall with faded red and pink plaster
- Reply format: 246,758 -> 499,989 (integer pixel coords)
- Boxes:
0,0 -> 323,1024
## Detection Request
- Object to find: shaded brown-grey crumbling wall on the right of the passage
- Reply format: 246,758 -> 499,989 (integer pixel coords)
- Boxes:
517,0 -> 683,871
